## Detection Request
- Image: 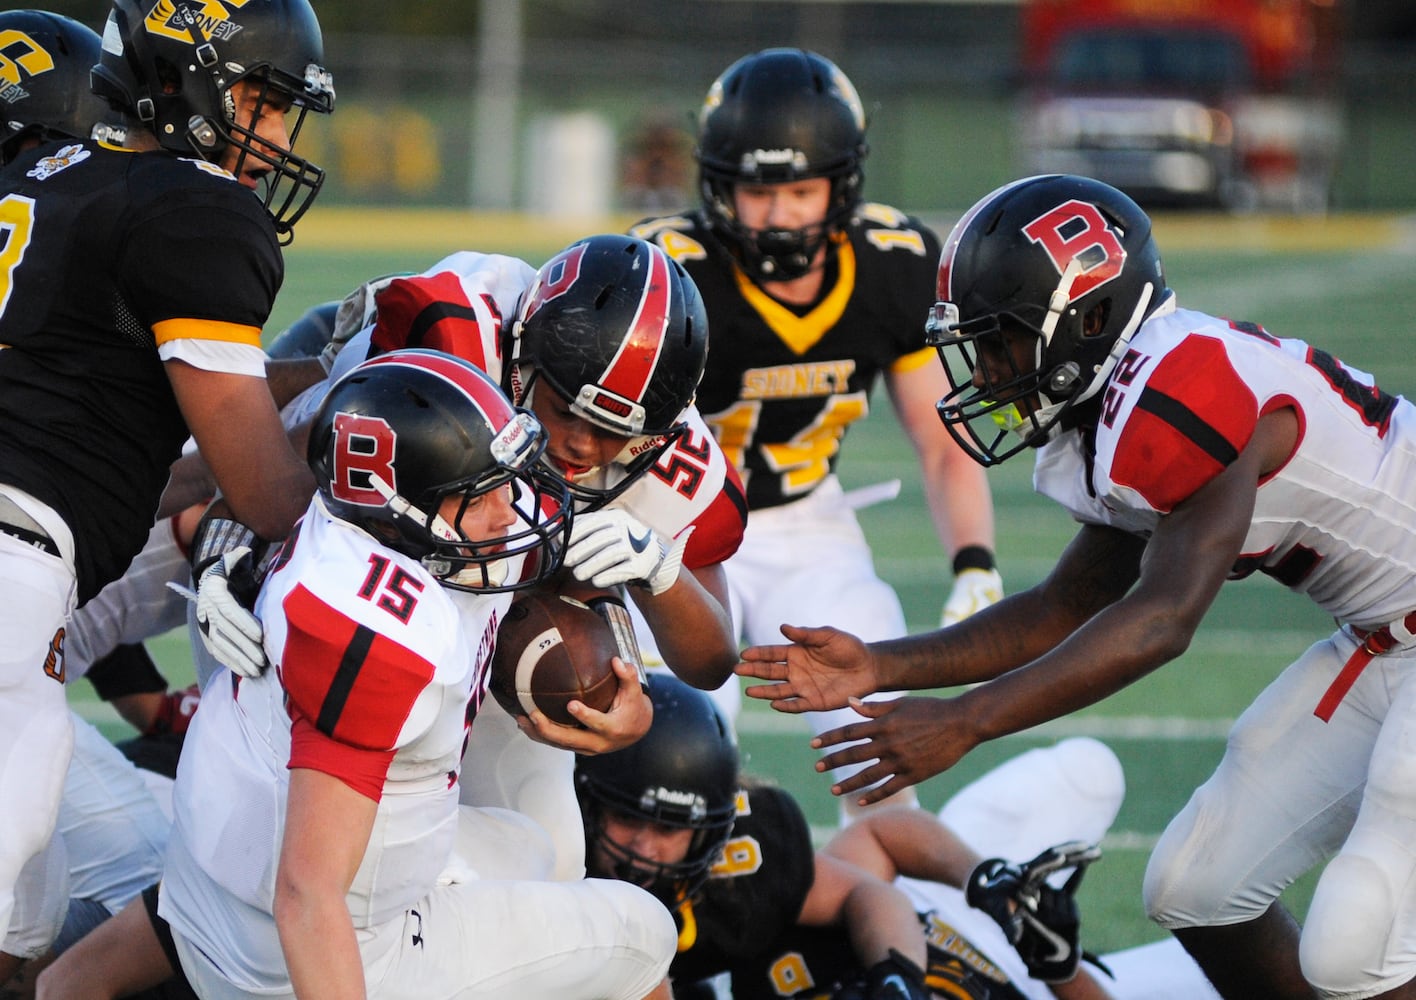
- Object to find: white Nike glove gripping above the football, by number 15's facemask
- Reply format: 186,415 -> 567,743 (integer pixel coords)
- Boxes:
565,510 -> 692,596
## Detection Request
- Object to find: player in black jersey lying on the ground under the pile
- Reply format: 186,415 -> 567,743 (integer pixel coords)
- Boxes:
576,674 -> 1214,1000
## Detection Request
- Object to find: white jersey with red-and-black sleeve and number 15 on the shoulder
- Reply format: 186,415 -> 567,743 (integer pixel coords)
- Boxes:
161,494 -> 511,986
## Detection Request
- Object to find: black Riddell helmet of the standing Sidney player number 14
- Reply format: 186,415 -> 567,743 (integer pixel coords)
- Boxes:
694,48 -> 867,280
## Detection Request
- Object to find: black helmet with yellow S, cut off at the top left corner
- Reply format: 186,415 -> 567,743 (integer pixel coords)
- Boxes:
0,10 -> 118,166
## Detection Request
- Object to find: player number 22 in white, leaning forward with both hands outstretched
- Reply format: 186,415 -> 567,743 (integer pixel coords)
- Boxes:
739,176 -> 1416,997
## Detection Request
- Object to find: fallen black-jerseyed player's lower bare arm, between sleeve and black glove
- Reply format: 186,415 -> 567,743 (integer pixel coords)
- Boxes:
797,851 -> 929,969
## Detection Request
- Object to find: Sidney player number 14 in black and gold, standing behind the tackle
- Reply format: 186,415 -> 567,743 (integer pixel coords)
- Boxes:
632,48 -> 1003,820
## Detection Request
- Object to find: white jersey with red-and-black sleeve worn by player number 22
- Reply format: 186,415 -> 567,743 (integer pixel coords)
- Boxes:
1034,300 -> 1416,627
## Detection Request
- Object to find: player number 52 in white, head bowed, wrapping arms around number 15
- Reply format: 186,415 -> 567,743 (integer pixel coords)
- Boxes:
202,234 -> 746,878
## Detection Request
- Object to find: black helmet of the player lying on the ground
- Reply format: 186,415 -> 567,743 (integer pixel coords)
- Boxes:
575,671 -> 738,911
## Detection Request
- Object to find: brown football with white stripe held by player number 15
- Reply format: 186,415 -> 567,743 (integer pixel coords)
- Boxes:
489,591 -> 619,725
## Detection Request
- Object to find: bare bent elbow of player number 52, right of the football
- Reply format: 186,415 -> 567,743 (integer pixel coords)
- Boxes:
624,562 -> 738,691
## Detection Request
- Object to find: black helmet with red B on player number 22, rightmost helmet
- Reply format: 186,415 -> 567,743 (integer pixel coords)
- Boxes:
926,174 -> 1170,466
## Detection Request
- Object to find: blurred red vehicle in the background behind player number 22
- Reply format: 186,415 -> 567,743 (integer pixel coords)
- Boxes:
1021,0 -> 1342,211
